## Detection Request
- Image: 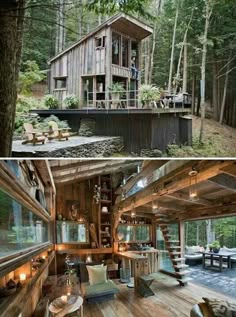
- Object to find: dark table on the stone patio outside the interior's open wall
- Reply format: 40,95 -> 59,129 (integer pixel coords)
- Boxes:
201,251 -> 236,272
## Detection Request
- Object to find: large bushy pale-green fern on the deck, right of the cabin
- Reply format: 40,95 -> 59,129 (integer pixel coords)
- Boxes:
139,85 -> 161,109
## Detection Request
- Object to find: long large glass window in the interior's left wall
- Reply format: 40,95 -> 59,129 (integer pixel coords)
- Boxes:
0,190 -> 48,258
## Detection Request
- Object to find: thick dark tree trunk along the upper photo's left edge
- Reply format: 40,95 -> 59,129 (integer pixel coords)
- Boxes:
0,0 -> 25,157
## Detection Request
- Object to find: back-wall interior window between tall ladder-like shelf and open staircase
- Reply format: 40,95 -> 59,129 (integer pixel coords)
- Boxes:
118,224 -> 151,242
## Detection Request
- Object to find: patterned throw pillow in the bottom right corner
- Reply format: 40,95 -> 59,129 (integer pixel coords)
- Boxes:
203,297 -> 236,317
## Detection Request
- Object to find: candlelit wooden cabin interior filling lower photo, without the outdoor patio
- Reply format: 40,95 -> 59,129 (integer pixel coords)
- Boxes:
0,159 -> 236,317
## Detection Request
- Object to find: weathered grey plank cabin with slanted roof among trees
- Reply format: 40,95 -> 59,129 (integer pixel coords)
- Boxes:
49,14 -> 153,108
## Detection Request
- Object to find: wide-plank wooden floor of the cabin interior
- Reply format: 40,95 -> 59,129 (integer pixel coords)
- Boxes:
84,274 -> 236,317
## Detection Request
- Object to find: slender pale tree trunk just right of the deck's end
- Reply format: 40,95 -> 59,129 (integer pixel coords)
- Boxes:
199,0 -> 213,143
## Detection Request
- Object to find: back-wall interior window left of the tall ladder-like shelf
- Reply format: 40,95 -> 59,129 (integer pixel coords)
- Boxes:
57,221 -> 89,243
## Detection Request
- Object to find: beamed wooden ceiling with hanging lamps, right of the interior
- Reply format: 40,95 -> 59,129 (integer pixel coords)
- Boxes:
114,160 -> 236,224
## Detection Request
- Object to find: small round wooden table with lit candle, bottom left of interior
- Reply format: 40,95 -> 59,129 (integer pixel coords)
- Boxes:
49,295 -> 83,317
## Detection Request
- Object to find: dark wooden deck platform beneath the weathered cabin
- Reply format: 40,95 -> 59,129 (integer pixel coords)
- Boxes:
31,108 -> 192,154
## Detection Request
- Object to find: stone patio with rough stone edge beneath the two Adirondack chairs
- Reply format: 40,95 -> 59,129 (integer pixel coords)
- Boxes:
12,136 -> 124,157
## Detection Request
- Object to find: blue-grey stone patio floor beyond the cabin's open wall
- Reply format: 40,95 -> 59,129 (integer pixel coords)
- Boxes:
188,265 -> 236,298
